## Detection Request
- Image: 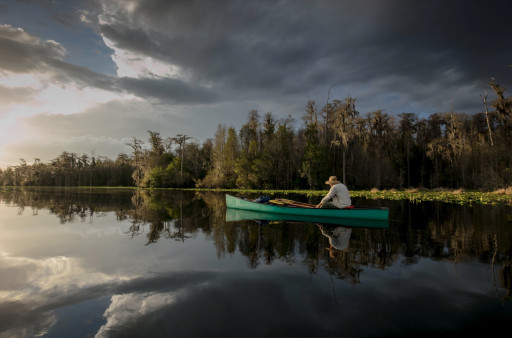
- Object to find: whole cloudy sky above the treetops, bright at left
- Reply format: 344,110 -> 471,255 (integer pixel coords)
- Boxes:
0,0 -> 512,168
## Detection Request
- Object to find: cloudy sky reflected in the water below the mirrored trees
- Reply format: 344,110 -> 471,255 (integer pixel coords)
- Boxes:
0,205 -> 512,337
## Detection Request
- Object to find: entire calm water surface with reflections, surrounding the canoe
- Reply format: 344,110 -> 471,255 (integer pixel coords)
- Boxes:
0,188 -> 512,337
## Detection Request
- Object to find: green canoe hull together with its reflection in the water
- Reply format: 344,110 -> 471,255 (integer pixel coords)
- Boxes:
226,195 -> 389,227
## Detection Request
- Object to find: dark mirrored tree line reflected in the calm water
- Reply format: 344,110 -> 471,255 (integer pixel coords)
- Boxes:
0,188 -> 512,299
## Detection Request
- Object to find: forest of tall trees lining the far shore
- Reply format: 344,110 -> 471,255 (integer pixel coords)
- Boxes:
0,79 -> 512,191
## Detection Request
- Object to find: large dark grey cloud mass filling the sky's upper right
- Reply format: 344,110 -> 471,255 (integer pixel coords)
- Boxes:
97,0 -> 512,113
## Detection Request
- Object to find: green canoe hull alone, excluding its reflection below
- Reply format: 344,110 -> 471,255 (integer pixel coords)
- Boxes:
226,195 -> 389,224
